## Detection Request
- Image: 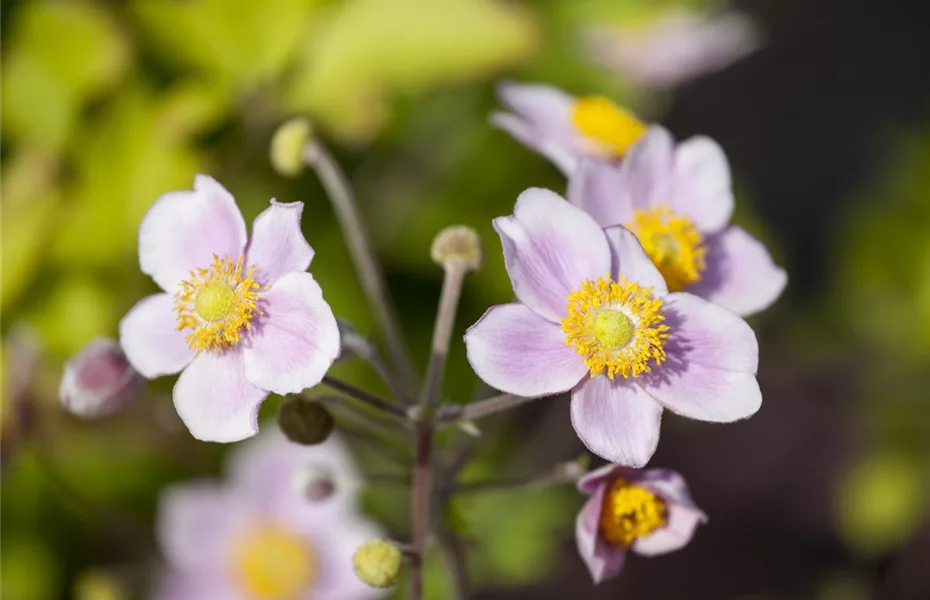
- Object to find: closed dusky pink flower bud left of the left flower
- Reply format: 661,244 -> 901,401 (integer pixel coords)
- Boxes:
59,338 -> 143,419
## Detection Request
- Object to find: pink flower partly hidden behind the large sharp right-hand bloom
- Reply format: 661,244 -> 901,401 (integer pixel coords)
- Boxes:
568,126 -> 788,315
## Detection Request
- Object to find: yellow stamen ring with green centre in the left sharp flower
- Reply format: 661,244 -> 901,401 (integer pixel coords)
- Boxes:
174,254 -> 262,352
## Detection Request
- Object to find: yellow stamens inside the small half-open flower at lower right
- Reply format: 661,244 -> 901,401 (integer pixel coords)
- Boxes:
600,479 -> 667,547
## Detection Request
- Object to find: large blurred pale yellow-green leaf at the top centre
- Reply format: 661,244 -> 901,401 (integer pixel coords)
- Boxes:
287,0 -> 539,139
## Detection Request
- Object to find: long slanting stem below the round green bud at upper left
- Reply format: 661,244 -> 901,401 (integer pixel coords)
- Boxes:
304,140 -> 416,386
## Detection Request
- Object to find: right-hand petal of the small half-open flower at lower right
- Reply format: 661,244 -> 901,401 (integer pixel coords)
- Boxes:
633,469 -> 707,556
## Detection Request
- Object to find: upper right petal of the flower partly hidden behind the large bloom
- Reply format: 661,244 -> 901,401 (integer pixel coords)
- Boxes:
666,136 -> 734,234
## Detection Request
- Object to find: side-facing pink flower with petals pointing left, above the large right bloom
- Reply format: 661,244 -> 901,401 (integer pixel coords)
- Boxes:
491,83 -> 646,175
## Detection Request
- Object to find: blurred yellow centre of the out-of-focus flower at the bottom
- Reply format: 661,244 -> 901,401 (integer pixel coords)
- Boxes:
233,527 -> 318,600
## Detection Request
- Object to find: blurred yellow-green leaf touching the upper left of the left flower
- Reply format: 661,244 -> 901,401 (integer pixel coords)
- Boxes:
53,85 -> 211,268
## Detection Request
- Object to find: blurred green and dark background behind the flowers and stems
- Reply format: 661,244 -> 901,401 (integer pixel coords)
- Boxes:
0,0 -> 930,600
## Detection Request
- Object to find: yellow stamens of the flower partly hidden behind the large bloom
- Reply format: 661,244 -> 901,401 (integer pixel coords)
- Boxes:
627,206 -> 707,292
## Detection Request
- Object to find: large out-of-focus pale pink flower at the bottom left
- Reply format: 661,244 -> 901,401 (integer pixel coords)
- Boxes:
156,431 -> 380,600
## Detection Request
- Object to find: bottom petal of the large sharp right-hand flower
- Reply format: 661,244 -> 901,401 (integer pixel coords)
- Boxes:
571,375 -> 662,467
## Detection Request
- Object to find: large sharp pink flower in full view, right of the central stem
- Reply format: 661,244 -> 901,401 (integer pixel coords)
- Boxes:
465,189 -> 762,466
